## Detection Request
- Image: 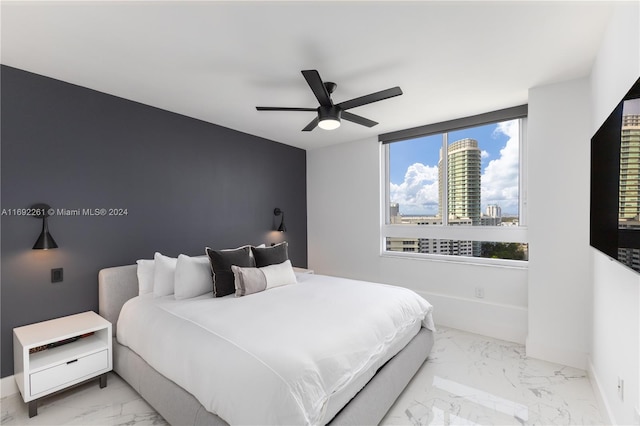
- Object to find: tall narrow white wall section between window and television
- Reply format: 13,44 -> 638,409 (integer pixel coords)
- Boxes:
527,78 -> 592,369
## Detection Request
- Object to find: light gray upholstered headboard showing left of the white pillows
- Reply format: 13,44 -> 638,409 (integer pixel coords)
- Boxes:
98,265 -> 138,336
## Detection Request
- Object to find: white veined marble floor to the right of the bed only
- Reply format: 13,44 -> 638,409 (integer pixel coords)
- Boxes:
381,327 -> 604,426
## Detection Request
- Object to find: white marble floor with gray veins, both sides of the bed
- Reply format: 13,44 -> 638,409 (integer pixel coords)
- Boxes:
0,327 -> 603,426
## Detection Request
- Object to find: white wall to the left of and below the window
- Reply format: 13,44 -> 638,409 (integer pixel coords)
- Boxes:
307,138 -> 527,342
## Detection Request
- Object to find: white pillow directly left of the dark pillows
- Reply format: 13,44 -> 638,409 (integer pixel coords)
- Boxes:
174,254 -> 213,300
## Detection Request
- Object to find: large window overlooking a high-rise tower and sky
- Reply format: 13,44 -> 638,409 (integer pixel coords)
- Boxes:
379,106 -> 528,263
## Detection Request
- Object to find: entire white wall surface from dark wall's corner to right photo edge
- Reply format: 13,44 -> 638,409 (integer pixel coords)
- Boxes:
307,2 -> 640,424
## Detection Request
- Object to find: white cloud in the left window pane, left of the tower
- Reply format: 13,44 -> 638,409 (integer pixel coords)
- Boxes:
389,163 -> 438,215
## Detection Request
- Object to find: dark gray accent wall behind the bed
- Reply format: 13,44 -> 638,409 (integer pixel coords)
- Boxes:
0,66 -> 307,377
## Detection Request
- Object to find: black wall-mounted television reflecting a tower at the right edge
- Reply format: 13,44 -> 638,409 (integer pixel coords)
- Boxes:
589,79 -> 640,272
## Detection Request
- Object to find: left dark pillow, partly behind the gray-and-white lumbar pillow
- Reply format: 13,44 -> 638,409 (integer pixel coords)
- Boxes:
206,246 -> 254,297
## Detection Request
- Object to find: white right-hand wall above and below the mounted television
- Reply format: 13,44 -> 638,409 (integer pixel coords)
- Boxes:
590,2 -> 640,424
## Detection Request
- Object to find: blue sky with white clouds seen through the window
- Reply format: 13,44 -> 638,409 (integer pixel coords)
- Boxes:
389,120 -> 519,216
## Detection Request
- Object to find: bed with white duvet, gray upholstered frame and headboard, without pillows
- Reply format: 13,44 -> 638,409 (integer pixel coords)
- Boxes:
98,253 -> 434,425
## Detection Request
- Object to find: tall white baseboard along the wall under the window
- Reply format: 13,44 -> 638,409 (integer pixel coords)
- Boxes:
416,291 -> 528,344
